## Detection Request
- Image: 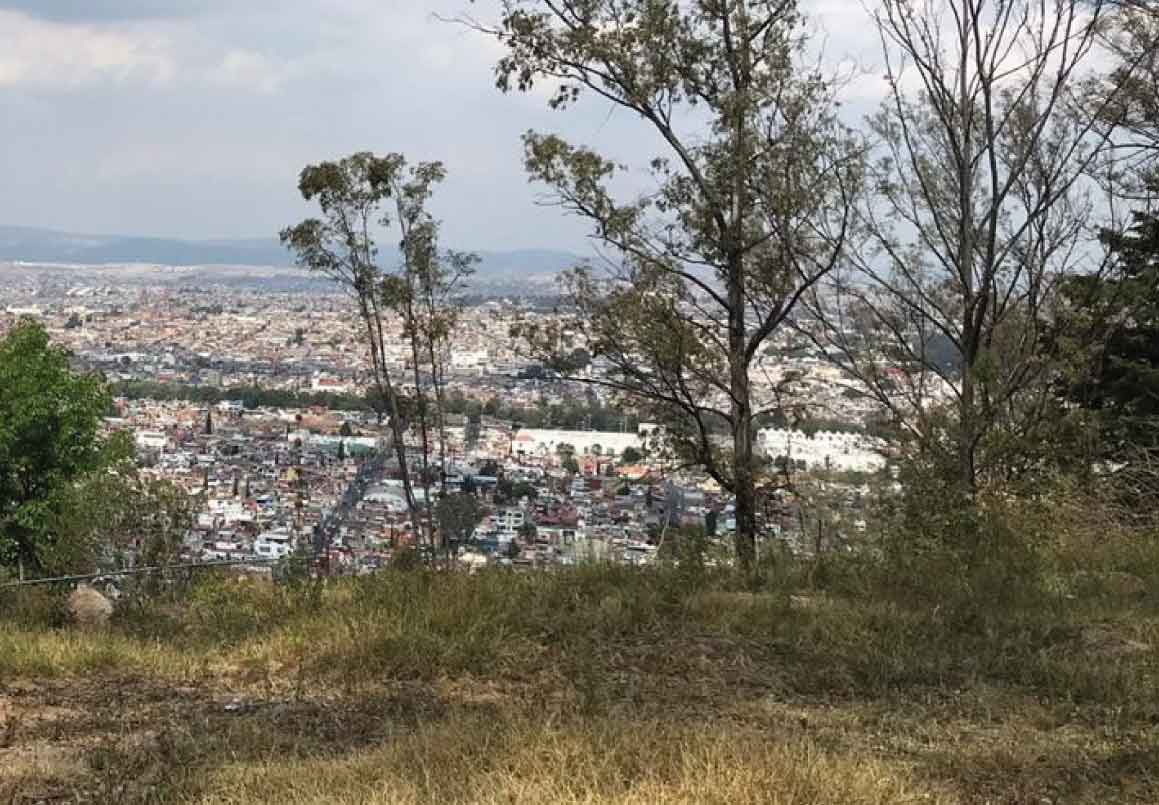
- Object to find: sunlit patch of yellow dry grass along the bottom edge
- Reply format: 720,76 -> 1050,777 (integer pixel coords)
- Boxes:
201,718 -> 950,805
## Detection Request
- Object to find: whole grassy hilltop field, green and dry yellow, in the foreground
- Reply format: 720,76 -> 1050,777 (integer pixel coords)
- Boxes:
0,553 -> 1159,805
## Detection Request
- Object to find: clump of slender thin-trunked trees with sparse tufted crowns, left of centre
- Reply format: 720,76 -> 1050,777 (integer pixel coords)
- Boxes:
282,153 -> 478,551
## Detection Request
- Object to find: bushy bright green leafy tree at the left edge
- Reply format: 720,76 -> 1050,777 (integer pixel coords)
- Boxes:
0,321 -> 131,572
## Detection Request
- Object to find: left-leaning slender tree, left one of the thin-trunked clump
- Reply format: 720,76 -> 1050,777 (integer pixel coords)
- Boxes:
280,153 -> 430,537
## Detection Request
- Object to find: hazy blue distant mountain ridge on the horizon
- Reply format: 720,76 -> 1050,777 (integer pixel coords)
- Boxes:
0,226 -> 582,280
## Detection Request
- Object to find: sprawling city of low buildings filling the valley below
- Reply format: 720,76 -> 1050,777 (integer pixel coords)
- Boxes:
0,263 -> 887,573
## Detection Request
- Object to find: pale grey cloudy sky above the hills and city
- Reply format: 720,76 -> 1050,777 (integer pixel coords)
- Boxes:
0,0 -> 880,250
